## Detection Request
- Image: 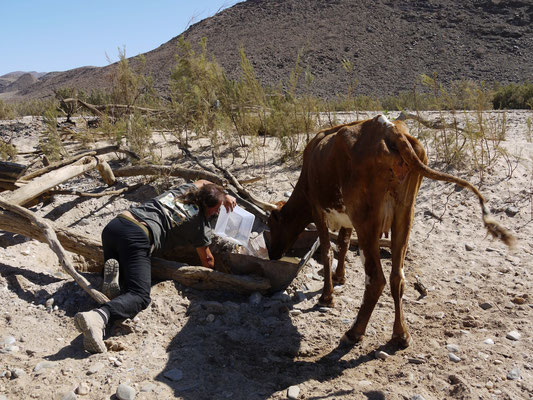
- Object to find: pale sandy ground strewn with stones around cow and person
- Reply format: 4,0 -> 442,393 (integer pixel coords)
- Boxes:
0,111 -> 533,400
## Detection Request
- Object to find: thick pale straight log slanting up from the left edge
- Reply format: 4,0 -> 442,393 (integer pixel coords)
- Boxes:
1,157 -> 97,205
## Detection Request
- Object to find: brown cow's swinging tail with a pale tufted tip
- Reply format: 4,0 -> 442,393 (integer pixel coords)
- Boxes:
387,129 -> 516,247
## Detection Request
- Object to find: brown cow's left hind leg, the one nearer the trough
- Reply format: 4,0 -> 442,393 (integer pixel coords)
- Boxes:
341,236 -> 386,344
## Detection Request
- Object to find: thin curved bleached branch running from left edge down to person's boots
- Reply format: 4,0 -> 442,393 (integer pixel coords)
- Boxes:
0,200 -> 109,304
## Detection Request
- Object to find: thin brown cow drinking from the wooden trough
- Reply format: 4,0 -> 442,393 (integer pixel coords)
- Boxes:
268,115 -> 514,347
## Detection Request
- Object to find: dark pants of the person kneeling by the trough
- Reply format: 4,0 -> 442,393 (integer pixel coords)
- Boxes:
101,217 -> 152,321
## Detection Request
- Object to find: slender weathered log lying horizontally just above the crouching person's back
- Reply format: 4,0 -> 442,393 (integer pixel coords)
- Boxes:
113,165 -> 226,185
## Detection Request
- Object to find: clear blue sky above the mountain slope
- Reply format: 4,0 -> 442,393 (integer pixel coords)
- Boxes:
0,0 -> 240,76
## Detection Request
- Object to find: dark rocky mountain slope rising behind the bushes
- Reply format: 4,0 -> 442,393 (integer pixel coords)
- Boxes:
0,0 -> 533,97
